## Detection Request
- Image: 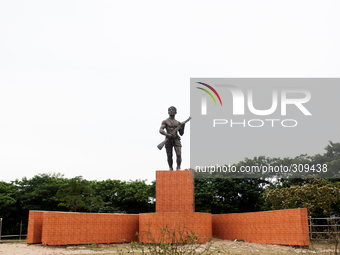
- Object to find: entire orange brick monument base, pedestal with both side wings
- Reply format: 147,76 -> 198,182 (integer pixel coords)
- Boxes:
27,170 -> 309,246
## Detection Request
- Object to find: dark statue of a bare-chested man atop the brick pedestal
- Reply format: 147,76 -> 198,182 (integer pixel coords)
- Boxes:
159,106 -> 185,171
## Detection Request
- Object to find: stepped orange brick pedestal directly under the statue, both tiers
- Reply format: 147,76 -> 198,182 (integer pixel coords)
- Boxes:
139,170 -> 212,243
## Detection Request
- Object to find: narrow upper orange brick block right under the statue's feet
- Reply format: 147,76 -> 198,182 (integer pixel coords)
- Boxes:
156,170 -> 195,212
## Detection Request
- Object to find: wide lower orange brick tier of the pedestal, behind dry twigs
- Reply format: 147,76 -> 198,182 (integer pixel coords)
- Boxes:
139,212 -> 212,243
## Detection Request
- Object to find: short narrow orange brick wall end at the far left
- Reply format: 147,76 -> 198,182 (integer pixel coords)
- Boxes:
27,211 -> 44,243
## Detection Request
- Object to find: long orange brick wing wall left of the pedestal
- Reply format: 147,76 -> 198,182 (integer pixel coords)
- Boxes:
27,212 -> 139,245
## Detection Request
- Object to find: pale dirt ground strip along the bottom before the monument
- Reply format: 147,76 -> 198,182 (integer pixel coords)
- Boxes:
0,239 -> 334,255
